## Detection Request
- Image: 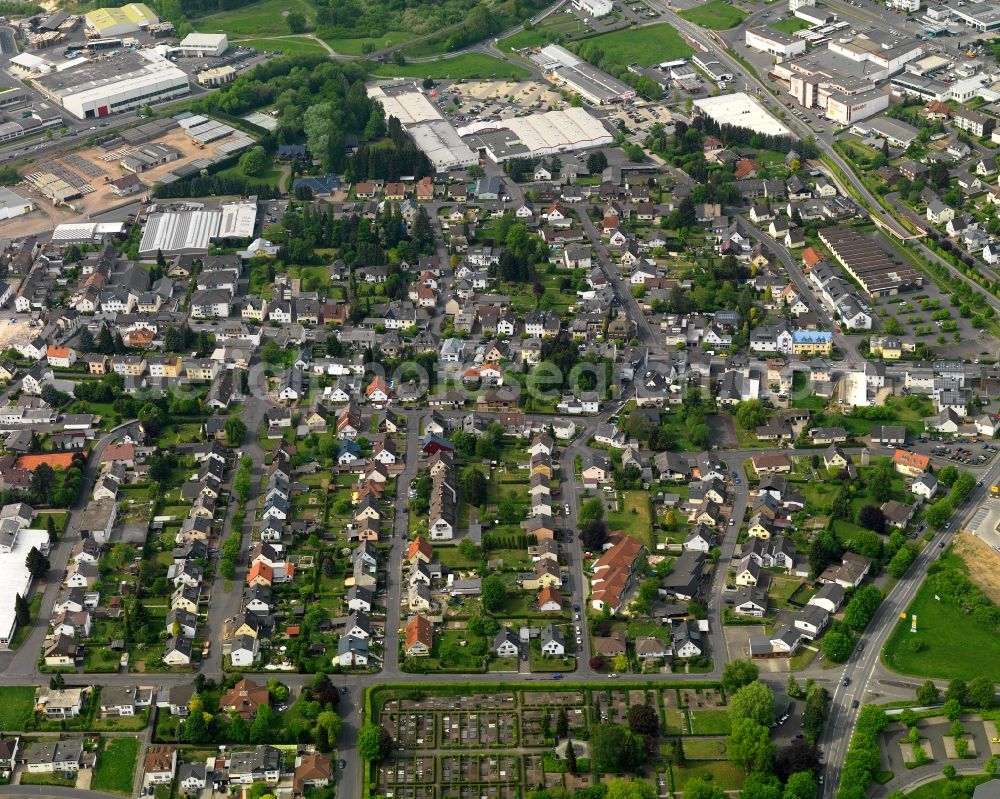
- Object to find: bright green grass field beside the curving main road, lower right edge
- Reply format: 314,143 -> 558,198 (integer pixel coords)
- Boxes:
882,551 -> 1000,682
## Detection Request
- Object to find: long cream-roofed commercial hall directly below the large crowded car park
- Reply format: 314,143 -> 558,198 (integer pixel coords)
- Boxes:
458,108 -> 614,163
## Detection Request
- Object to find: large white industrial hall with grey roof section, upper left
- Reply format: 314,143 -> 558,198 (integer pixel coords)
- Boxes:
35,50 -> 190,119
